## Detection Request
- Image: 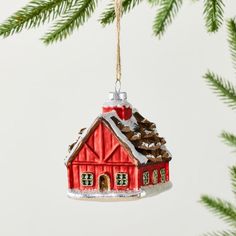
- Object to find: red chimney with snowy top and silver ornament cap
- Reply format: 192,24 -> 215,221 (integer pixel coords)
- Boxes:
102,92 -> 132,120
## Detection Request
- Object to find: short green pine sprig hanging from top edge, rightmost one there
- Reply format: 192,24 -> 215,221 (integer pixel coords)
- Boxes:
203,0 -> 224,32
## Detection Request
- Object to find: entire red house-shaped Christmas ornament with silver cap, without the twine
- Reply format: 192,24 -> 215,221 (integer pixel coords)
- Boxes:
65,92 -> 171,200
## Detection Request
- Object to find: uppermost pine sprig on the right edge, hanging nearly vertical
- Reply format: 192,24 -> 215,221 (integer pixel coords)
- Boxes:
227,19 -> 236,70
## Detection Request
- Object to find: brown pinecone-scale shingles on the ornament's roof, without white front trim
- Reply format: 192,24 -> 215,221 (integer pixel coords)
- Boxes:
66,111 -> 171,163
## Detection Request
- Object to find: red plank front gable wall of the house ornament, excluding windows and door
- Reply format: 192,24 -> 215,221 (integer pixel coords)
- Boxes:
67,121 -> 139,190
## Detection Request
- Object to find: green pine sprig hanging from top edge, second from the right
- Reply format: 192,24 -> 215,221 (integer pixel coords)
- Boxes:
153,0 -> 183,36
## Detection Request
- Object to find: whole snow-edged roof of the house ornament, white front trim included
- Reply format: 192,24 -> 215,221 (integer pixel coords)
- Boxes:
65,109 -> 171,165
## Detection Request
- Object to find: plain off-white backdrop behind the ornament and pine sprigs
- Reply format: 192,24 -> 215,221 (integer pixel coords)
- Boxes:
0,0 -> 236,236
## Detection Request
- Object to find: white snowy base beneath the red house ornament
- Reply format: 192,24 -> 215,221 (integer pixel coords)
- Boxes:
67,181 -> 172,201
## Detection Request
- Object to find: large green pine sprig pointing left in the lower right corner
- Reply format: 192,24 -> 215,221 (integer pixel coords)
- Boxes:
201,195 -> 236,226
